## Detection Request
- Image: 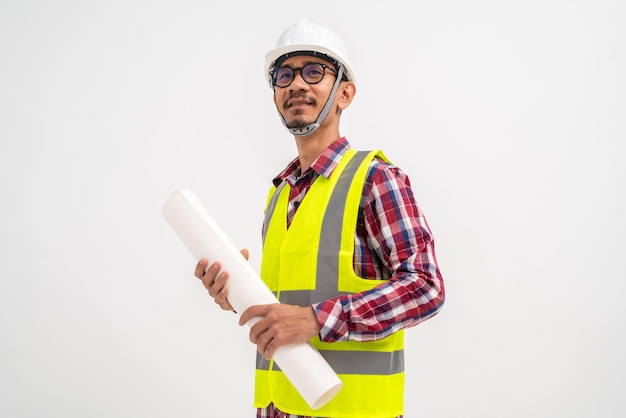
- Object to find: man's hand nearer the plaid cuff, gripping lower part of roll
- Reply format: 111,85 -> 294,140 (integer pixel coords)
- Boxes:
239,303 -> 320,359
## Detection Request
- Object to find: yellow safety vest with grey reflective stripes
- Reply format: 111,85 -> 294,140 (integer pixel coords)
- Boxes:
254,150 -> 404,418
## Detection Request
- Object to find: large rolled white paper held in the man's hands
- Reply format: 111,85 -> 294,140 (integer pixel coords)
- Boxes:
161,190 -> 343,409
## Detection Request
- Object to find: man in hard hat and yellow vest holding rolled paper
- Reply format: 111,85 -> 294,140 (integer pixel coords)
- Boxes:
195,20 -> 444,418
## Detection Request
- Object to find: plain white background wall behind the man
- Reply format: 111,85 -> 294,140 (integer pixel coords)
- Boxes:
0,0 -> 626,418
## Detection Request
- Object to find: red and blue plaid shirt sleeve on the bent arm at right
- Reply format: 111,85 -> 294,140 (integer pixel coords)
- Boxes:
313,162 -> 444,342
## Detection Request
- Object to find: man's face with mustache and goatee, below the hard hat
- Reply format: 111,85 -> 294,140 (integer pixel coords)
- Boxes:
274,55 -> 336,128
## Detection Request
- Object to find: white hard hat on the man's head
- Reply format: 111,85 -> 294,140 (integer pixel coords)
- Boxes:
265,19 -> 355,87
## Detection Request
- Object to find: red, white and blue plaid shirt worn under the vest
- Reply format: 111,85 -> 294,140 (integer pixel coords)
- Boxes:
257,138 -> 444,418
